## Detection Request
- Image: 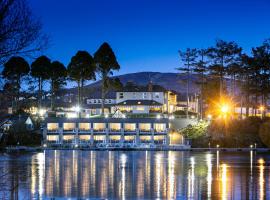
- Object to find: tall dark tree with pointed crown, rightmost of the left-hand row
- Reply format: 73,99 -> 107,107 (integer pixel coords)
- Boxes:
94,42 -> 120,115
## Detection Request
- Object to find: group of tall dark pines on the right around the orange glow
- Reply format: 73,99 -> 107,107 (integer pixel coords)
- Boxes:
177,40 -> 270,116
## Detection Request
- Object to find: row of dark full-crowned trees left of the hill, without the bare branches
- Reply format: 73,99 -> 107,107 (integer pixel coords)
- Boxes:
2,42 -> 120,113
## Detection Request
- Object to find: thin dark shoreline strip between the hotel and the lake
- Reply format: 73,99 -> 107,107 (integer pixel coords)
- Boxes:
1,146 -> 270,152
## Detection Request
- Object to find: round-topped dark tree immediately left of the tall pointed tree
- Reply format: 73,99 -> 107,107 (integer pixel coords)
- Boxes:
67,51 -> 96,106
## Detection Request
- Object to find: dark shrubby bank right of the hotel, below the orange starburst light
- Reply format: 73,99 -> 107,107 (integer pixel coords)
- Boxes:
181,117 -> 270,148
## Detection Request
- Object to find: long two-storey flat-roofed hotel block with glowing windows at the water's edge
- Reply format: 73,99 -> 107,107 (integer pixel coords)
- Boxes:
43,118 -> 169,147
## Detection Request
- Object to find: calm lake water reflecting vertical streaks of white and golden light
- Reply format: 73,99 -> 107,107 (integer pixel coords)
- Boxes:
0,150 -> 270,199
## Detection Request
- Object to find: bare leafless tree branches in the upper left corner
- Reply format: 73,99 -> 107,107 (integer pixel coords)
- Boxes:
0,0 -> 48,64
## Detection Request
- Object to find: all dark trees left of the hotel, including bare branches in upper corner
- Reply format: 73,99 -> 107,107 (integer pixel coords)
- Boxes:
0,0 -> 120,115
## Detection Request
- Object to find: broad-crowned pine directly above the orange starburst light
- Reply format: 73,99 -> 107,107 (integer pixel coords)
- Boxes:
208,40 -> 242,98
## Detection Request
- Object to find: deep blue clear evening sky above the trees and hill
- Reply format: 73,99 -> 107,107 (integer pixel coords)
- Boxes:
29,0 -> 270,74
